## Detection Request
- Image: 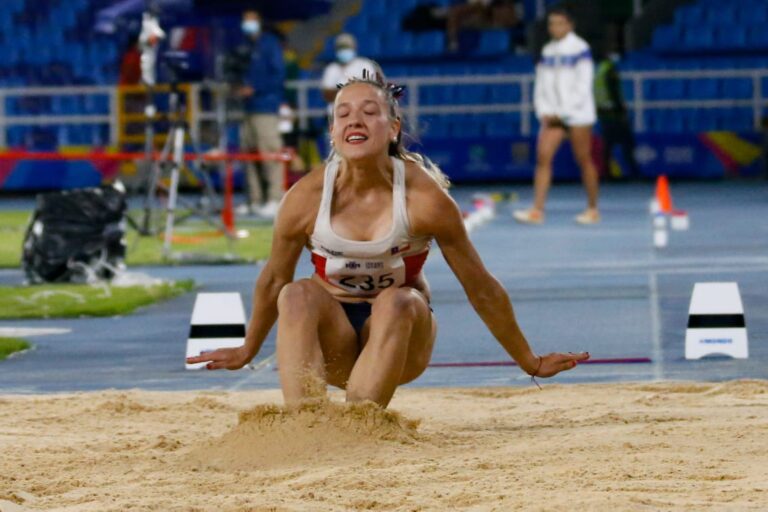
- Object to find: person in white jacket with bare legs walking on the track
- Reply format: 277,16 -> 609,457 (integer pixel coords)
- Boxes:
513,8 -> 600,224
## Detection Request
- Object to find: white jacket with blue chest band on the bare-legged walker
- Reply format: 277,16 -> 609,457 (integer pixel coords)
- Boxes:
533,32 -> 597,126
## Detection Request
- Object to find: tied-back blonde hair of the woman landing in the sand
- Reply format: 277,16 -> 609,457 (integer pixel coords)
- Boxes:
328,69 -> 451,189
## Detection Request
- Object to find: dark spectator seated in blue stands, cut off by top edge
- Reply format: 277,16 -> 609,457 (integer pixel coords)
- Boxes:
445,0 -> 520,52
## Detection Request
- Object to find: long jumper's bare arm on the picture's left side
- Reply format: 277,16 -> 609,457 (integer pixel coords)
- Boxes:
187,175 -> 319,370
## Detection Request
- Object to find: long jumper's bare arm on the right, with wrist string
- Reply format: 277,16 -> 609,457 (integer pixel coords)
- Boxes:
411,180 -> 589,377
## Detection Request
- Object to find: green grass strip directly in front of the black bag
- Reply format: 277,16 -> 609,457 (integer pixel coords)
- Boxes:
0,280 -> 195,319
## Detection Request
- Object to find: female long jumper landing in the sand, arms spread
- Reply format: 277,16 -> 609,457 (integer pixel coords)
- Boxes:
187,74 -> 589,407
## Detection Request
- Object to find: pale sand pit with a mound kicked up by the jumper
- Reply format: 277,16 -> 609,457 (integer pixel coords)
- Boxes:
0,381 -> 768,512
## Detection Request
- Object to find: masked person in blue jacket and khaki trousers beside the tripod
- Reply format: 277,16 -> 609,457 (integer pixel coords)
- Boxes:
236,9 -> 285,218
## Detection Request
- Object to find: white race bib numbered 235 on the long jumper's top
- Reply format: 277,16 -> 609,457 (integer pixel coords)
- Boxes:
325,257 -> 405,295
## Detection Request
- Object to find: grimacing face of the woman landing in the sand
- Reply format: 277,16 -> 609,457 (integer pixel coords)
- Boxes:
331,83 -> 400,160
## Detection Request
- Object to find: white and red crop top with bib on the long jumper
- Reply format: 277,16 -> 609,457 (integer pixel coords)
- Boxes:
309,157 -> 431,298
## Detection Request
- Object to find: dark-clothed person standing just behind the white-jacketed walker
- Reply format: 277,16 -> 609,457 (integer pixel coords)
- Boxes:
595,52 -> 640,178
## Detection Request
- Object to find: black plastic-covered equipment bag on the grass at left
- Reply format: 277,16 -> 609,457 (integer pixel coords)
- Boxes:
22,186 -> 127,283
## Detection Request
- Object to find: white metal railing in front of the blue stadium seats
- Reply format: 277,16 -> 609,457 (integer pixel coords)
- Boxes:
0,69 -> 768,147
